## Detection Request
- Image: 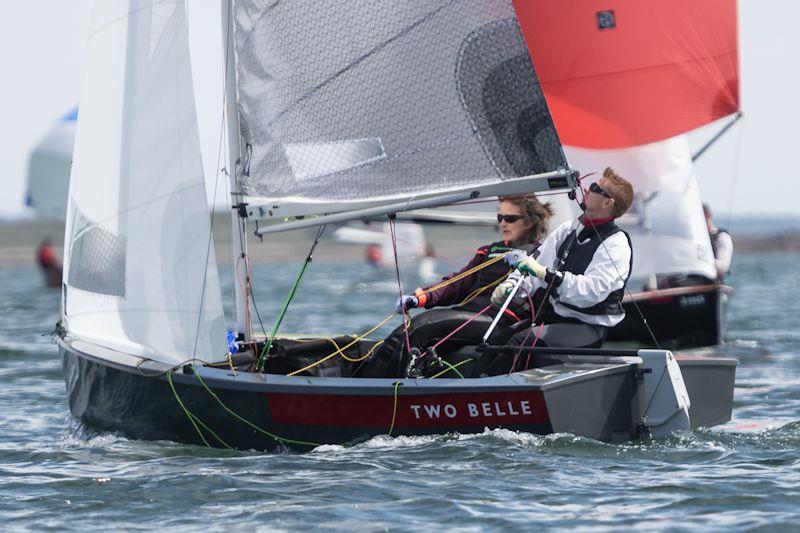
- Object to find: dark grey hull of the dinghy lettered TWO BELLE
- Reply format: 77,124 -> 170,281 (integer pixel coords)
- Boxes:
58,336 -> 736,451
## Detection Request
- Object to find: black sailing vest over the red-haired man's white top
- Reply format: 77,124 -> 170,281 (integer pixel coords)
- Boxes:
556,221 -> 633,315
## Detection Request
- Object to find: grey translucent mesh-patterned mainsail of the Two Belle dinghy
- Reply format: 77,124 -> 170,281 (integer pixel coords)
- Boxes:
234,0 -> 567,218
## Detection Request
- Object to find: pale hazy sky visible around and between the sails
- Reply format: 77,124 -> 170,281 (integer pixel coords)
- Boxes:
0,0 -> 800,218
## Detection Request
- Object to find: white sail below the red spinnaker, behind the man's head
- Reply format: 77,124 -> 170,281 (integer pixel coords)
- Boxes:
559,135 -> 716,291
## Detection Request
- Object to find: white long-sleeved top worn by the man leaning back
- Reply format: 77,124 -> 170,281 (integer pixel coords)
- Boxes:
509,220 -> 632,327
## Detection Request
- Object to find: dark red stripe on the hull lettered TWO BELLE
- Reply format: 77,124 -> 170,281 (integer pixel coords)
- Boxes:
266,391 -> 549,428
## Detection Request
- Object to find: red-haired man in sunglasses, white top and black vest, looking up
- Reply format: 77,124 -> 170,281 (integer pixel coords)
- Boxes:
492,168 -> 633,348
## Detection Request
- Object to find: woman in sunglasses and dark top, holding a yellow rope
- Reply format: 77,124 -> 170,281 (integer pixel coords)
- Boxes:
356,195 -> 553,377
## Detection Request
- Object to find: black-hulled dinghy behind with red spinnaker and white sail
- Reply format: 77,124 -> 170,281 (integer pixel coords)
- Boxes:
514,0 -> 742,348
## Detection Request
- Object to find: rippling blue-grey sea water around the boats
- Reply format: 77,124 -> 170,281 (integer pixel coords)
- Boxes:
0,253 -> 800,531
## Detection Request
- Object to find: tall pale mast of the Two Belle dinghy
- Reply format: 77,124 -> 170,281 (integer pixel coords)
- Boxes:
221,0 -> 252,341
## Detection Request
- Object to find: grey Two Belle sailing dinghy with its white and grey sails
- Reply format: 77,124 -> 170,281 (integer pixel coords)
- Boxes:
57,0 -> 736,450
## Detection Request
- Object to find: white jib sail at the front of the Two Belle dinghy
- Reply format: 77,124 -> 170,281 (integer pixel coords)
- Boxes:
63,0 -> 226,363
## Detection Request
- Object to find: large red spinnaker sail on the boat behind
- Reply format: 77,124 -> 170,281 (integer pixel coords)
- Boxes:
513,0 -> 739,149
